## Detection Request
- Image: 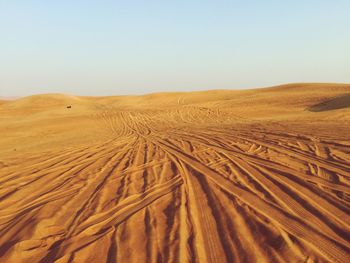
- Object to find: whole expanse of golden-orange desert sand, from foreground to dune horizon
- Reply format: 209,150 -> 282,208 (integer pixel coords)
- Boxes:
0,84 -> 350,263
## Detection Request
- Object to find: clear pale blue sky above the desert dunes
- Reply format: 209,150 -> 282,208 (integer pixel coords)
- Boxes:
0,0 -> 350,96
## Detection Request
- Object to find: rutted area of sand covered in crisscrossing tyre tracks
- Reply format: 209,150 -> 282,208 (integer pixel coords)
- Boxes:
0,97 -> 350,262
